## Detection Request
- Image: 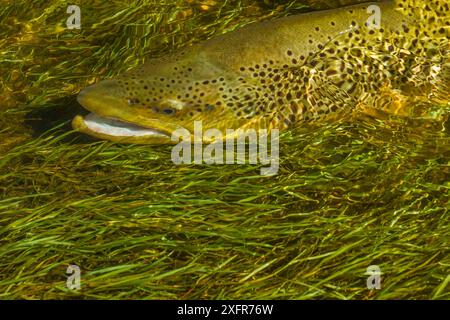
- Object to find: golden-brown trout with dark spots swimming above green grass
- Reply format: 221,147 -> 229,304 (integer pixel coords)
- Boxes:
73,0 -> 450,144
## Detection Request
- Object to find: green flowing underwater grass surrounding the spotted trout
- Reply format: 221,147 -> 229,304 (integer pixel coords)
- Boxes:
0,1 -> 450,299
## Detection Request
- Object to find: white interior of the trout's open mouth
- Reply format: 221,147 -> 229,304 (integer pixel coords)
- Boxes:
84,113 -> 165,137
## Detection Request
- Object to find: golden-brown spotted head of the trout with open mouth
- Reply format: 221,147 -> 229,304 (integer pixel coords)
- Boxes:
72,53 -> 253,144
